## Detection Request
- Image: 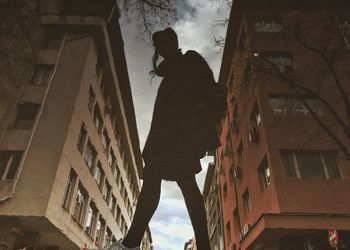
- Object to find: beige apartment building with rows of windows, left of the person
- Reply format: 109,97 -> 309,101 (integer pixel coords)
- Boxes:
0,0 -> 151,250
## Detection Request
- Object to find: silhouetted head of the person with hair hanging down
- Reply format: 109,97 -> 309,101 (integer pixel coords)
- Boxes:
152,28 -> 179,73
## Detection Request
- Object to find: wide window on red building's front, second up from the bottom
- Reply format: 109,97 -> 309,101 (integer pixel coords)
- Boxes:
269,96 -> 319,116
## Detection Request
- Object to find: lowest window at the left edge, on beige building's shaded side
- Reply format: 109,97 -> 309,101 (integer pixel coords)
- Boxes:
0,150 -> 22,180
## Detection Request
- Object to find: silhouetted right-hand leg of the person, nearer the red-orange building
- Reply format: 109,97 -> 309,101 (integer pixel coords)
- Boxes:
177,175 -> 210,250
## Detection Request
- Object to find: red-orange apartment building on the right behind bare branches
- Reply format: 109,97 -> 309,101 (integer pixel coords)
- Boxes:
218,0 -> 350,250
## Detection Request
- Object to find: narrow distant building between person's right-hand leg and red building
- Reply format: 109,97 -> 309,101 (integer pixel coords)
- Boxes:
203,160 -> 224,250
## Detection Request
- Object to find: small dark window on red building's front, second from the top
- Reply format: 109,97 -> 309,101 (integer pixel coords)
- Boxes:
262,52 -> 294,73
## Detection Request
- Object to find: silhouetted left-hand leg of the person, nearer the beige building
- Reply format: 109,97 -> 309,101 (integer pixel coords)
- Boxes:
123,173 -> 162,248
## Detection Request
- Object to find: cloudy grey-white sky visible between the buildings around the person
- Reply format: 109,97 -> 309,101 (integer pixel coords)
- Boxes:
121,0 -> 230,250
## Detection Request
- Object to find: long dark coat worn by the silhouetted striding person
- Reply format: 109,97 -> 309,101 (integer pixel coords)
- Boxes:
142,51 -> 219,180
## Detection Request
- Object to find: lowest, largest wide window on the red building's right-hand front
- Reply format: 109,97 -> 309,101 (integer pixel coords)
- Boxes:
281,151 -> 341,179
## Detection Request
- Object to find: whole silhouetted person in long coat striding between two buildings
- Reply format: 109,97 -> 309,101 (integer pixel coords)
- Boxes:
111,28 -> 219,250
